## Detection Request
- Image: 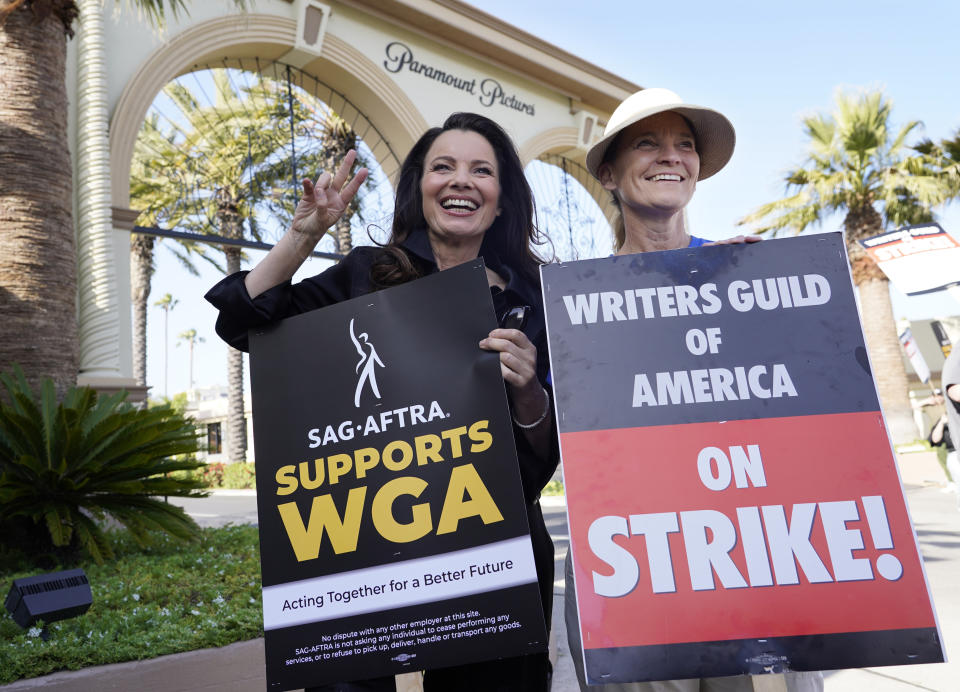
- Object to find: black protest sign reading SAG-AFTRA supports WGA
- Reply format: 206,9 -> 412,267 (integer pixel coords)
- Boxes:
250,260 -> 546,690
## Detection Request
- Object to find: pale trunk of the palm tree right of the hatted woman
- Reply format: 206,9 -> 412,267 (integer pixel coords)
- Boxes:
844,204 -> 921,444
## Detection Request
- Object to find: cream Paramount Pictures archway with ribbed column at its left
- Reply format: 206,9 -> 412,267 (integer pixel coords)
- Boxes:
67,0 -> 639,399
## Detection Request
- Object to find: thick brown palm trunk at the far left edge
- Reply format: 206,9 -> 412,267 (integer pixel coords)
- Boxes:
0,8 -> 78,394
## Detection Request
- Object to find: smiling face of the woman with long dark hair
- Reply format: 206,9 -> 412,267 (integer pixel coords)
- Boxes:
420,130 -> 500,249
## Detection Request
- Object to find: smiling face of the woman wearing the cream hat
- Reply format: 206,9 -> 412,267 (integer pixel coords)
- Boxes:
598,111 -> 700,216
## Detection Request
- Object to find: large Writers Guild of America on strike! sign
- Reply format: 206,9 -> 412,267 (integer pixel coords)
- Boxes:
542,233 -> 943,683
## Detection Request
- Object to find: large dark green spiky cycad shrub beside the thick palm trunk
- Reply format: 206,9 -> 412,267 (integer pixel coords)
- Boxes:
0,367 -> 205,563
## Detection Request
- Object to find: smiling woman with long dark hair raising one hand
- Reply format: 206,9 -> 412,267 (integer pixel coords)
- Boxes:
206,113 -> 559,692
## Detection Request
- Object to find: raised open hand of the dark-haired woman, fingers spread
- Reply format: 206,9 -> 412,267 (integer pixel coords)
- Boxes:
291,149 -> 368,244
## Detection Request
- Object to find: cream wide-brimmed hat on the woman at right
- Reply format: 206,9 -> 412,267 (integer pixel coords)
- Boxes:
587,89 -> 737,180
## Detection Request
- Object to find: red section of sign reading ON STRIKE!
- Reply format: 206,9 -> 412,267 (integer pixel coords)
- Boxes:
561,411 -> 935,649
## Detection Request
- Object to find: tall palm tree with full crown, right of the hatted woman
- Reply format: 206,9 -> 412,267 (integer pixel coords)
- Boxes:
739,91 -> 950,443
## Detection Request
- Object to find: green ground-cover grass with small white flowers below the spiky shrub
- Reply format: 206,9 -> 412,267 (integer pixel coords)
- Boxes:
0,526 -> 263,684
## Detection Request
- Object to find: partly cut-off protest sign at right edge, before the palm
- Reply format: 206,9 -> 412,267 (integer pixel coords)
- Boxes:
860,223 -> 960,296
